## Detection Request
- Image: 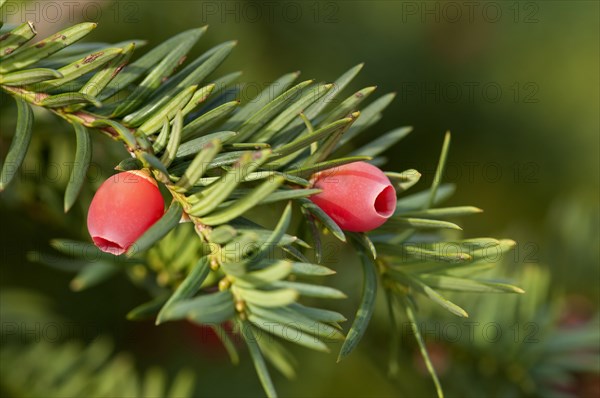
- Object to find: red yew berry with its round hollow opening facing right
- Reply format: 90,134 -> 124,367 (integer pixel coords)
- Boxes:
310,162 -> 396,232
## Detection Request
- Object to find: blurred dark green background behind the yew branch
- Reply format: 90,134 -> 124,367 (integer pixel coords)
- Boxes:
0,0 -> 600,397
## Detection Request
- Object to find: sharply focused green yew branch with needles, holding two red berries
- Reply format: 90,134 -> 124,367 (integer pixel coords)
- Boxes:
0,13 -> 522,396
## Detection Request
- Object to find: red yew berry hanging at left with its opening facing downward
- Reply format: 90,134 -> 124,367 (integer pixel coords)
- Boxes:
87,170 -> 164,255
